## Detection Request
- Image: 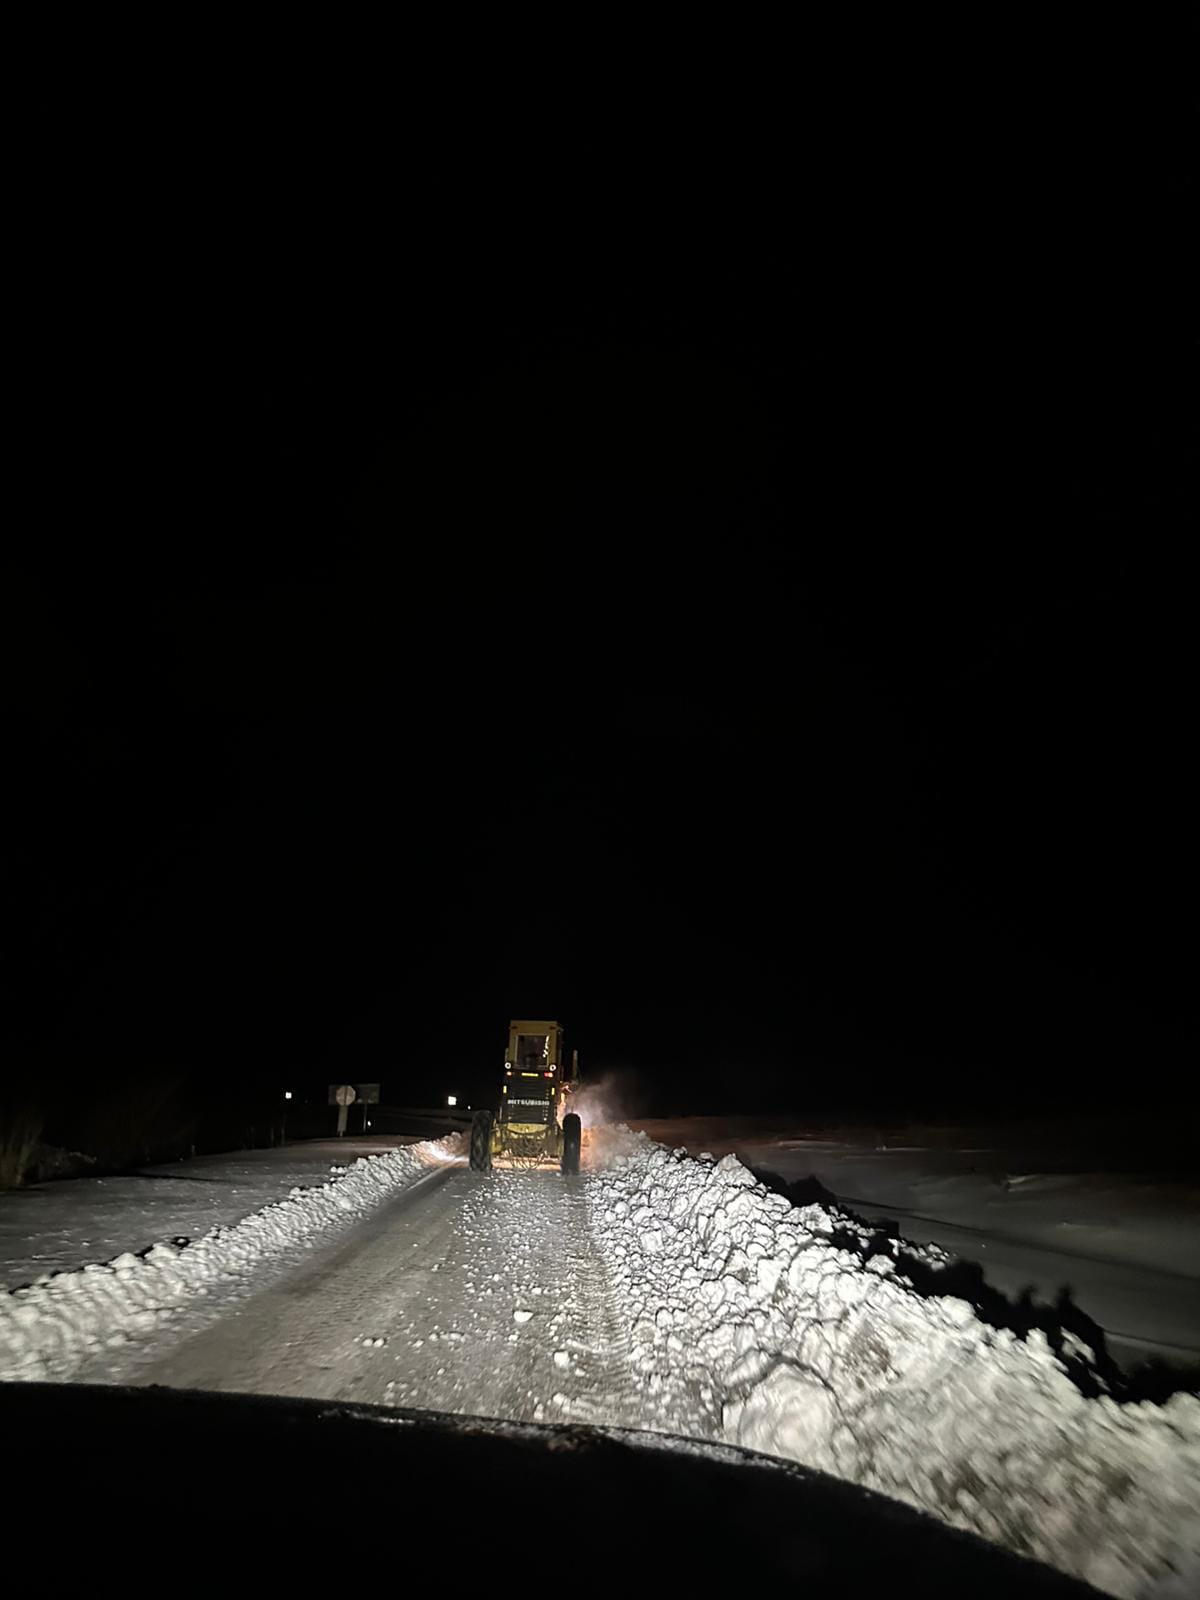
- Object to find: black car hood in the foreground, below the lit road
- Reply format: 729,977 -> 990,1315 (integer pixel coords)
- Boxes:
0,1384 -> 1094,1600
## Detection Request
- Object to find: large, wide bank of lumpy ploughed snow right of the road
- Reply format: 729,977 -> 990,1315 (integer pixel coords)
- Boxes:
589,1139 -> 1200,1597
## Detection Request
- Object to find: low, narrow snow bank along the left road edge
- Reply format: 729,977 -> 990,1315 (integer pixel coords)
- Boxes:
0,1141 -> 456,1379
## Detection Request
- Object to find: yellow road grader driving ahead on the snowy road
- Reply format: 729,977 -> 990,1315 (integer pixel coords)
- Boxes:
470,1021 -> 581,1173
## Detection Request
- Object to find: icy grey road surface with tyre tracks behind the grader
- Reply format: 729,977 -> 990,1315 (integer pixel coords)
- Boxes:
138,1168 -> 651,1426
